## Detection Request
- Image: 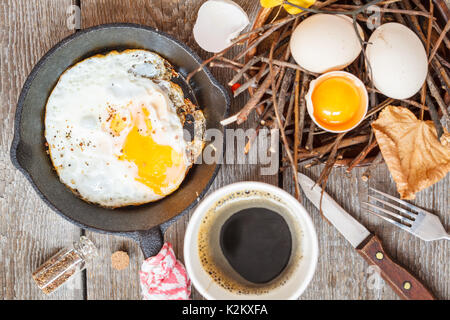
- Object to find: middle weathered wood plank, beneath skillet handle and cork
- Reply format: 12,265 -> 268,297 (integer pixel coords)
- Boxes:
82,0 -> 264,299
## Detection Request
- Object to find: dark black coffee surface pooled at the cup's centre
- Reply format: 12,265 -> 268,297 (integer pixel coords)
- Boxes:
220,207 -> 292,284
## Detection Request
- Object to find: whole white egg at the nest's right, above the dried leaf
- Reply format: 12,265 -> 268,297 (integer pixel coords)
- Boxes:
366,22 -> 428,99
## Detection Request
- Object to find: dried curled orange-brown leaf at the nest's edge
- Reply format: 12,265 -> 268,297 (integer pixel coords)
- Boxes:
372,106 -> 450,199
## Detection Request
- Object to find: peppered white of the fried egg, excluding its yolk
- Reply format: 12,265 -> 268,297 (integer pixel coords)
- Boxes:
45,50 -> 191,207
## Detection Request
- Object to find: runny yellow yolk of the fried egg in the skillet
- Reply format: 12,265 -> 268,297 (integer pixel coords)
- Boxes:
119,108 -> 186,195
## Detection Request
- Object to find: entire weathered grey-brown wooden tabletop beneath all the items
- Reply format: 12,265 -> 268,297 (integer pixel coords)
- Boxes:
0,0 -> 450,299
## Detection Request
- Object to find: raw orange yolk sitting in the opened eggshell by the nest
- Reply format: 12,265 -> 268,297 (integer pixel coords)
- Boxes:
311,77 -> 361,125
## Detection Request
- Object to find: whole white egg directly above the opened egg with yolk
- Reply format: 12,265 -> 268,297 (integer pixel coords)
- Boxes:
290,14 -> 364,73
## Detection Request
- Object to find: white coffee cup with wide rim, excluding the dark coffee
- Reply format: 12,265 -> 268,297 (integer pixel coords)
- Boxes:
184,182 -> 319,300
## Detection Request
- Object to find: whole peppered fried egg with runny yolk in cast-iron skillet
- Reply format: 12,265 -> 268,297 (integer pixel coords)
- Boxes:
45,50 -> 202,207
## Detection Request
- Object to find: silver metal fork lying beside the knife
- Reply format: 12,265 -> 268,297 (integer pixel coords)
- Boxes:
362,187 -> 450,241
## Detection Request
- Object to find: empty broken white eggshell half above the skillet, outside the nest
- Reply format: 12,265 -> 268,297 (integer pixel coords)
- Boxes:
193,0 -> 249,52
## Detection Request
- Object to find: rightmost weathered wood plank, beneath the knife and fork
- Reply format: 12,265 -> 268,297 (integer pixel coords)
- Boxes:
283,164 -> 450,299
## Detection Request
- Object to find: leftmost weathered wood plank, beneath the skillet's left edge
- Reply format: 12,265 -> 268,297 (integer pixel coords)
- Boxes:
0,0 -> 84,299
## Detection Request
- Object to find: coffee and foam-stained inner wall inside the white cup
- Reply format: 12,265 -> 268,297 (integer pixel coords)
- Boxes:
197,190 -> 302,295
